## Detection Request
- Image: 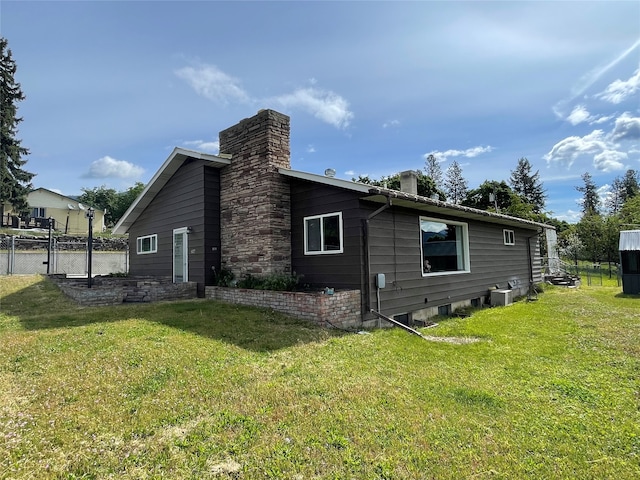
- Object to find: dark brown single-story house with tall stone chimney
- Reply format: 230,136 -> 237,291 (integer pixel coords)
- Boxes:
114,110 -> 553,320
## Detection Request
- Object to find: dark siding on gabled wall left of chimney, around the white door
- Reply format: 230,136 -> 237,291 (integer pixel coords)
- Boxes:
129,160 -> 220,294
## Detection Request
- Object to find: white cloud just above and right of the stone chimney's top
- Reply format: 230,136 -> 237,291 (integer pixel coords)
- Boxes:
272,87 -> 353,129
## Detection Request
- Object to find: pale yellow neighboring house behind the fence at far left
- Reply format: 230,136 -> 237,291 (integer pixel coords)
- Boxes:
3,188 -> 105,235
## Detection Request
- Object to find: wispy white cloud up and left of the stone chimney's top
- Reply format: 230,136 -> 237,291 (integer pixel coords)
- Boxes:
175,65 -> 250,104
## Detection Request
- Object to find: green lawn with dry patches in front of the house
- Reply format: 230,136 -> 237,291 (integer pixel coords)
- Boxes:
0,276 -> 640,480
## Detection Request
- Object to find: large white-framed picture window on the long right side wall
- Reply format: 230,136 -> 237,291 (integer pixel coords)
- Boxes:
420,217 -> 470,275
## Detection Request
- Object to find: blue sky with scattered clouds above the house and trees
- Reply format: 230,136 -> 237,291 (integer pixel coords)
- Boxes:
0,0 -> 640,222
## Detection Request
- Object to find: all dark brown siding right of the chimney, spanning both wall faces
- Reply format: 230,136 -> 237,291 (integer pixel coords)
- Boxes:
291,180 -> 541,316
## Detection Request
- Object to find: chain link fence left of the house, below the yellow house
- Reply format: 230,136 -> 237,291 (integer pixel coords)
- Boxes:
0,237 -> 129,276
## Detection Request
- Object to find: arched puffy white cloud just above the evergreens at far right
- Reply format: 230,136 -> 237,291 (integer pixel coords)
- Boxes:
543,130 -> 627,172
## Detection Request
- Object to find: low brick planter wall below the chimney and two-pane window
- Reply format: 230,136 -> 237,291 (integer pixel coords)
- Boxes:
205,287 -> 362,328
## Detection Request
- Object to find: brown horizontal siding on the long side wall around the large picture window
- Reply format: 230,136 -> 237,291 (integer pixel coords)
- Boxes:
370,208 -> 540,315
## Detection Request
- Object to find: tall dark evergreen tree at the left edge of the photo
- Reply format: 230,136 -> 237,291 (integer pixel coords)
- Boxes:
0,37 -> 34,221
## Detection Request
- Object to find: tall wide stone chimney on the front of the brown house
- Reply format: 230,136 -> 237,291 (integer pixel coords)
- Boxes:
219,110 -> 291,278
